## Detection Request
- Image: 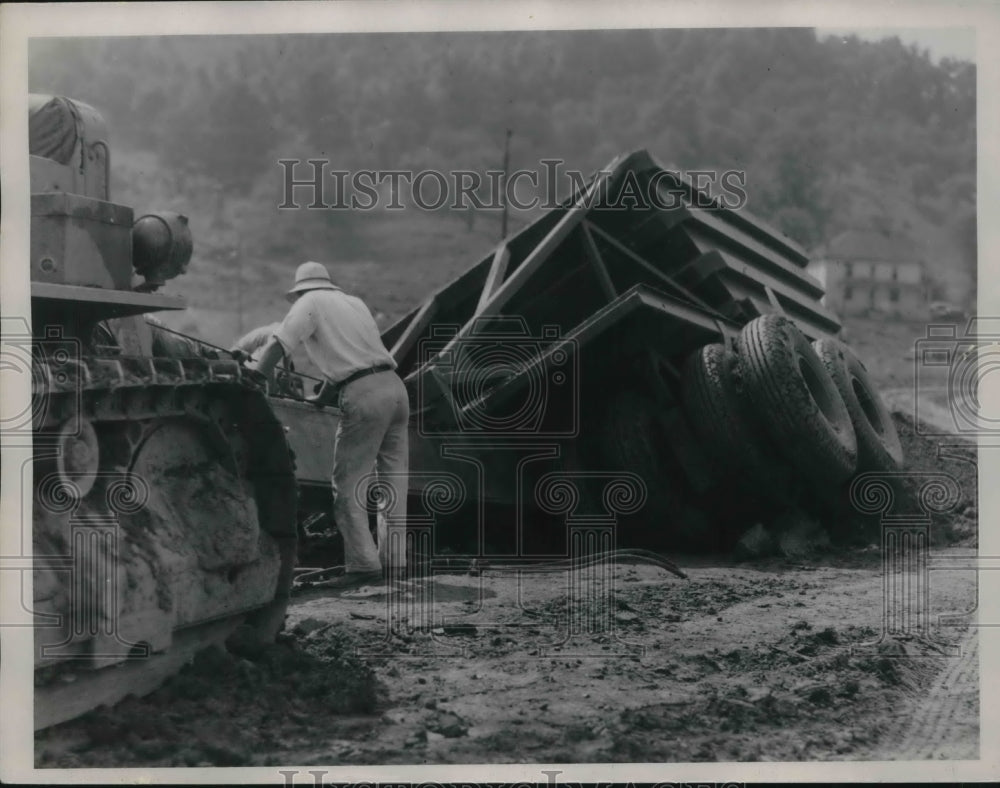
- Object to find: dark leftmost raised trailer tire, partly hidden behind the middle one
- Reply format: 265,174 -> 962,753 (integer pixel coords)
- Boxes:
681,343 -> 794,502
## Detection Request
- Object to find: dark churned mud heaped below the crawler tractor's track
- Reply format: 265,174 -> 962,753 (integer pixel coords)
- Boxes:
36,627 -> 380,768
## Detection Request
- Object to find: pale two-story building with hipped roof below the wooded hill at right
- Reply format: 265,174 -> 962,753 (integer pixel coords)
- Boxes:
808,230 -> 928,320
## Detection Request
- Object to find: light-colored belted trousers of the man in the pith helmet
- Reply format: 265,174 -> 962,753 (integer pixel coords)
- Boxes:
333,372 -> 410,572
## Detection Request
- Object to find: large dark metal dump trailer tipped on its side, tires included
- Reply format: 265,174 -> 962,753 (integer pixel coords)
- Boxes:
372,151 -> 902,557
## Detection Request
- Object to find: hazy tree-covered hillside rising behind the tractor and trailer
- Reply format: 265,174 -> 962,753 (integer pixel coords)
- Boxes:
30,29 -> 976,341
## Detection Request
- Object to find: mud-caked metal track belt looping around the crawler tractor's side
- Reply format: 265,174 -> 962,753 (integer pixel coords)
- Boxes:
32,357 -> 298,729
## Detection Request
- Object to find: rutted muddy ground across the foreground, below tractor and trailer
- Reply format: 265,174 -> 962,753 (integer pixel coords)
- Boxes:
36,416 -> 979,767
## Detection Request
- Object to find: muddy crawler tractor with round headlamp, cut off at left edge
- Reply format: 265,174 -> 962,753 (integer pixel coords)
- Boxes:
26,96 -> 297,729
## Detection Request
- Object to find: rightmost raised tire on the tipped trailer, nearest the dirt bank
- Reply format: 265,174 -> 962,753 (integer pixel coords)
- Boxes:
813,339 -> 903,472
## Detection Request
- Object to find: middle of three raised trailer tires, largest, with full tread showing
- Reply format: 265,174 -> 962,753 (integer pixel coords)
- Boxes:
738,314 -> 858,490
